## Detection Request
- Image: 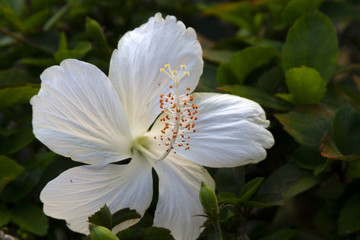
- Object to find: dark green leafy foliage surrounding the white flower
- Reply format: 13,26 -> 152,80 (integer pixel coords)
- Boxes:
0,0 -> 360,240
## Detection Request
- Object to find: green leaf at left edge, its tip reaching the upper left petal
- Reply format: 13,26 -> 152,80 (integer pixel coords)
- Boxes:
0,84 -> 39,109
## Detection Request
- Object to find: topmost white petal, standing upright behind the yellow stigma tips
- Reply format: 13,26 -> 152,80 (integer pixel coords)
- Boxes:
109,14 -> 203,136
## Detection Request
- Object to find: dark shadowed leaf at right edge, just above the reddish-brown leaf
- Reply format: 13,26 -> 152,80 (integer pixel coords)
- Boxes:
333,104 -> 360,155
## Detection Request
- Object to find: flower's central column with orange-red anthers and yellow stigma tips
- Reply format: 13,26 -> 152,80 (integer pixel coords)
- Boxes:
154,64 -> 198,160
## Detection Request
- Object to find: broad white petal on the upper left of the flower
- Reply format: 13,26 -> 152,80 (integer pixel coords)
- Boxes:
31,59 -> 131,164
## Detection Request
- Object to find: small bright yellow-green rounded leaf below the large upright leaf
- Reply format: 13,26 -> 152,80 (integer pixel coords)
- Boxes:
285,66 -> 326,104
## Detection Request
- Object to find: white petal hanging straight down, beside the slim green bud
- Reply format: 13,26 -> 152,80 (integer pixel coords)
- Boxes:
154,154 -> 215,240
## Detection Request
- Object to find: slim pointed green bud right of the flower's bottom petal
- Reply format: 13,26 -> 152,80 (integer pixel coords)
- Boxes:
199,182 -> 219,218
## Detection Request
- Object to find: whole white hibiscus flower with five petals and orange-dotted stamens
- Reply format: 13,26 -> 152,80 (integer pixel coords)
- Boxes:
31,14 -> 274,240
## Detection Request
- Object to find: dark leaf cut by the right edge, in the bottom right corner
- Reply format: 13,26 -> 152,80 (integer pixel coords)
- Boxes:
338,193 -> 360,234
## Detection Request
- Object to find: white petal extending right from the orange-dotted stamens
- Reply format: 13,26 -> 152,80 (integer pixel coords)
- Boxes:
148,93 -> 274,167
